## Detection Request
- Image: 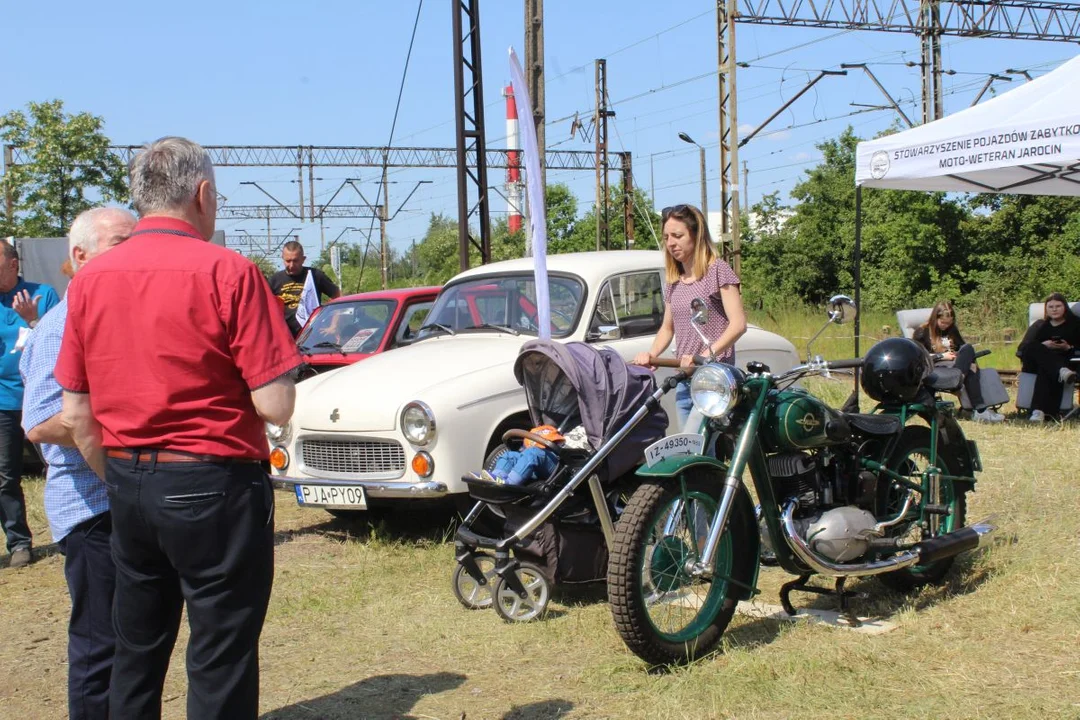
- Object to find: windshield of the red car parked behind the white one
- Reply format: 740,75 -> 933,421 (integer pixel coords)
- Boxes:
296,300 -> 397,354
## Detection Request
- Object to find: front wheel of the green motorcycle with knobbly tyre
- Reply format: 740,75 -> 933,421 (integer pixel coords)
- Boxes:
608,473 -> 753,665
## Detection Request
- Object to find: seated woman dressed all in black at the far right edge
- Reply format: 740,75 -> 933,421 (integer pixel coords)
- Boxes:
1016,293 -> 1080,422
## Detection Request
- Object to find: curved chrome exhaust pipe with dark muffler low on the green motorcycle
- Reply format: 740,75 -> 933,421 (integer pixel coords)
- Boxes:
780,500 -> 997,578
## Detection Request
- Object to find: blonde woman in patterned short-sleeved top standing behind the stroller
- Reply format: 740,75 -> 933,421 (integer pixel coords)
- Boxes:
634,205 -> 746,424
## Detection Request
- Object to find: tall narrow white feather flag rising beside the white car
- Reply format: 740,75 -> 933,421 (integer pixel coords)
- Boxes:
510,47 -> 551,340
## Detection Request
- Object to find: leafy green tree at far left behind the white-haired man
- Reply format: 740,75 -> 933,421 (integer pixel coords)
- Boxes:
0,99 -> 127,237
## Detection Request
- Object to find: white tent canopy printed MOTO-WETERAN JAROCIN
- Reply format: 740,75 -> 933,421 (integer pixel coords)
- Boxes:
855,56 -> 1080,195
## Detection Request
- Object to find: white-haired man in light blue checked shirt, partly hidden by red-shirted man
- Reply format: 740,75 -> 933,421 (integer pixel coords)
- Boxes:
20,207 -> 135,720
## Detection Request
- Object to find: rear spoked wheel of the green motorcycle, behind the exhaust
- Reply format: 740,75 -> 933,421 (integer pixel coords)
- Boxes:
878,425 -> 968,593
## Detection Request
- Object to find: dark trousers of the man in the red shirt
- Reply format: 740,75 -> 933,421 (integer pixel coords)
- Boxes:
105,458 -> 273,720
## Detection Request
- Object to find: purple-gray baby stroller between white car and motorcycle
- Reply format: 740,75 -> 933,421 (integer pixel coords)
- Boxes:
453,340 -> 667,622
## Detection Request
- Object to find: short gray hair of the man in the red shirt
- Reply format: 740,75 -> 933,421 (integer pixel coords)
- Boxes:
129,137 -> 214,217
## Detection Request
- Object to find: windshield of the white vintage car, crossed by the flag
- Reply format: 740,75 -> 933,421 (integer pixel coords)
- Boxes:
420,273 -> 584,338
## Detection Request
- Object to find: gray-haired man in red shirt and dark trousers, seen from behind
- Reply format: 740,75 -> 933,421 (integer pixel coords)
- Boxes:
55,137 -> 300,720
